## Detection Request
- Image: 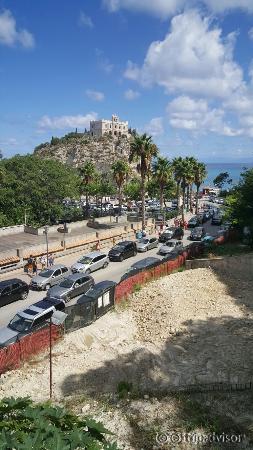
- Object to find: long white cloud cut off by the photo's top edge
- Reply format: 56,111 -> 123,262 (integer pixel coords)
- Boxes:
103,0 -> 253,19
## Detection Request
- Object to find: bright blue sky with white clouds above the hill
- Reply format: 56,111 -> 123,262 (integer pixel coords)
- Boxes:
0,0 -> 253,163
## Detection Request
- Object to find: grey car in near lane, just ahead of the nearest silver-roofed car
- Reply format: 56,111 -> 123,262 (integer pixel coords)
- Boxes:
47,273 -> 95,303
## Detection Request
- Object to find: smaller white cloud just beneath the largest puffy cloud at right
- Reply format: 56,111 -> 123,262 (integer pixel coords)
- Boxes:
167,96 -> 241,136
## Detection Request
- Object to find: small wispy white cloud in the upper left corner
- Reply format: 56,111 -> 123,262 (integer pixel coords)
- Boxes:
0,10 -> 35,48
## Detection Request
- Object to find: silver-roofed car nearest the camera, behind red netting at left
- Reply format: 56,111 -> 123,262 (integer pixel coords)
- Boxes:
0,300 -> 65,348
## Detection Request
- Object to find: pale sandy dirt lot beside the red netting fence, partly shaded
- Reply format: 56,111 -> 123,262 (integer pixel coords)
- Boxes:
0,269 -> 253,450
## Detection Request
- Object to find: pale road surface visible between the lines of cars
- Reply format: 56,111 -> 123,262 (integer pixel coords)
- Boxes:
0,203 -> 220,327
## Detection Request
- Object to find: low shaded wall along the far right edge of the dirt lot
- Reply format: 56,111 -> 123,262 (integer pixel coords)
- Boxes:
186,253 -> 253,279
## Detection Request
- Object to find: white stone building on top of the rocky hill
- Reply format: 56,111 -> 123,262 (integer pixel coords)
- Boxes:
90,115 -> 129,137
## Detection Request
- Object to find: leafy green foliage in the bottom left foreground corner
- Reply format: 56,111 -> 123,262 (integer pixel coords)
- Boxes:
0,397 -> 117,450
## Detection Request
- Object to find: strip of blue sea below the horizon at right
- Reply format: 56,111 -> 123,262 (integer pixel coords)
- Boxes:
203,163 -> 253,188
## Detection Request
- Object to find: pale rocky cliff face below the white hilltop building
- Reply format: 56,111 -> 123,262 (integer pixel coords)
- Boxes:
34,133 -> 130,172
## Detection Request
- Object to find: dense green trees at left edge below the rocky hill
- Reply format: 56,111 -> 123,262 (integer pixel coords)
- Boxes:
0,155 -> 80,226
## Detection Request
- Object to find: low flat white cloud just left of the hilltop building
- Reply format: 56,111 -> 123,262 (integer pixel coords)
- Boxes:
38,112 -> 97,130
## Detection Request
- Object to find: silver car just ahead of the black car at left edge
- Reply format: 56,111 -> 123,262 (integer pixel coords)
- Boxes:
30,264 -> 71,291
